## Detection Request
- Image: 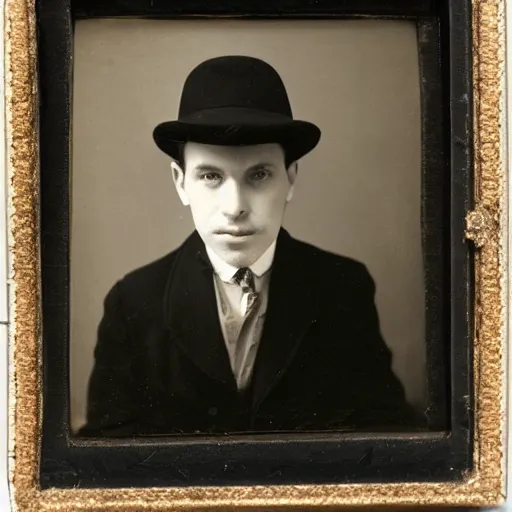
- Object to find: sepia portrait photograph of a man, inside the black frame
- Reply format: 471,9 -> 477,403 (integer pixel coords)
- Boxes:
70,20 -> 428,437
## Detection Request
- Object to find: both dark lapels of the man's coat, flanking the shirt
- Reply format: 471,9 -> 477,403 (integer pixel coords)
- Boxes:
164,229 -> 317,407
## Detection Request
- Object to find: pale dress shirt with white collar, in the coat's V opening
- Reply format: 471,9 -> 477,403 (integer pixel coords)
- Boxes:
206,242 -> 276,389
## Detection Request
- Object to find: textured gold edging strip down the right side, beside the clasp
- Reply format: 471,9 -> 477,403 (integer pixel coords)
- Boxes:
473,0 -> 507,502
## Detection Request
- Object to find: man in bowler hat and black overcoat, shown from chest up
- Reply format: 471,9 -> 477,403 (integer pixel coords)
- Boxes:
81,56 -> 419,436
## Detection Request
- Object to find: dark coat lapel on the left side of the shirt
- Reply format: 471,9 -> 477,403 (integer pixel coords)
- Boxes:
164,231 -> 236,389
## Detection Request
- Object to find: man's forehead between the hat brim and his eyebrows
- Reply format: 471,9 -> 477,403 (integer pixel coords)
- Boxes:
184,142 -> 284,170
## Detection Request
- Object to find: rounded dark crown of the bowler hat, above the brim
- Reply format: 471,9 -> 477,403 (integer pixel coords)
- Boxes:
179,56 -> 292,118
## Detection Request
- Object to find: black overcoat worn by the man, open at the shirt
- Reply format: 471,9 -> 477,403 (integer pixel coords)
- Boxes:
80,229 -> 422,436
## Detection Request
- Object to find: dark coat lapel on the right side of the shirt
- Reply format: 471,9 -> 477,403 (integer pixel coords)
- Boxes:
252,229 -> 318,410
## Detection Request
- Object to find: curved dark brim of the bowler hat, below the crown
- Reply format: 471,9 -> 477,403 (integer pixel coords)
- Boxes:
153,108 -> 321,161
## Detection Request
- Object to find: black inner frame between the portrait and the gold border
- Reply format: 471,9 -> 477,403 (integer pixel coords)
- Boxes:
36,0 -> 473,488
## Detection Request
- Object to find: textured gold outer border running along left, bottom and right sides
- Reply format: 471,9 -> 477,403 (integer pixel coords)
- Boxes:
4,0 -> 506,512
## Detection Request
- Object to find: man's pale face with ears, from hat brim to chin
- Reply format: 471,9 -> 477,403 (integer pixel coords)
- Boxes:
172,142 -> 297,267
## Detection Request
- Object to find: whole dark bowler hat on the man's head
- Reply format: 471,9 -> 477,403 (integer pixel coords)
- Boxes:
153,56 -> 320,162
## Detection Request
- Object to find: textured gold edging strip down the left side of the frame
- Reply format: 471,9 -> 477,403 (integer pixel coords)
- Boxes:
4,0 -> 40,511
